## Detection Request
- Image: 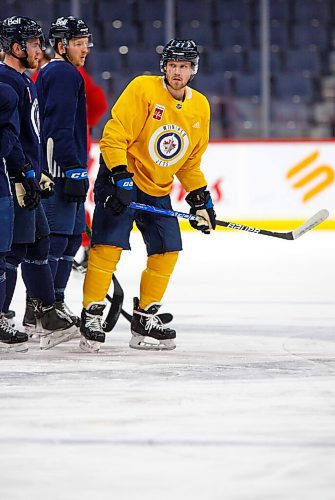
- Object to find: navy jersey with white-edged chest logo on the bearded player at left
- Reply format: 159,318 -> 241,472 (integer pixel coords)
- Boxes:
0,63 -> 42,179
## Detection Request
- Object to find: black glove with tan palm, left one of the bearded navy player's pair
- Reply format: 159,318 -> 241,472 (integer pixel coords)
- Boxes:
14,164 -> 41,210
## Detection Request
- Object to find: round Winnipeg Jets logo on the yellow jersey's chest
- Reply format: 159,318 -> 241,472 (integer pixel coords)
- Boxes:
149,124 -> 189,167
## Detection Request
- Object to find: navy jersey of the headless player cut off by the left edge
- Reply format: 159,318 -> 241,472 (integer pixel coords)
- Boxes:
0,82 -> 25,197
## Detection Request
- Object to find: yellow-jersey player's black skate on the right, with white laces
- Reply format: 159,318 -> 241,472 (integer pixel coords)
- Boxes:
129,297 -> 176,351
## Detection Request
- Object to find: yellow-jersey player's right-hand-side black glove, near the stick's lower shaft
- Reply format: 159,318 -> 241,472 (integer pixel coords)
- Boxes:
185,186 -> 216,234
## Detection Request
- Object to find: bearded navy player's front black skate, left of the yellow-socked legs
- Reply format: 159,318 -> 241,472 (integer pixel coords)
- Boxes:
32,299 -> 78,349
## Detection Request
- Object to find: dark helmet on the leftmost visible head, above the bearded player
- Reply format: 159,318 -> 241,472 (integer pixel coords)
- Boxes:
0,16 -> 45,53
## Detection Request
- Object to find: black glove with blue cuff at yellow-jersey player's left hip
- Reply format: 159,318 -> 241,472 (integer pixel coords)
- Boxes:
104,165 -> 134,215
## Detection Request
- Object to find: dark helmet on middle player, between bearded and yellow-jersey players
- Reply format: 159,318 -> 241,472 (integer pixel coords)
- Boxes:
49,16 -> 93,48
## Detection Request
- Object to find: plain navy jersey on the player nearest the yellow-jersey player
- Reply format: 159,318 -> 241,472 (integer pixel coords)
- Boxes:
36,59 -> 87,177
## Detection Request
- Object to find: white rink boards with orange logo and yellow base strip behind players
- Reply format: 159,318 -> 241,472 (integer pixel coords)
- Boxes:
88,140 -> 335,229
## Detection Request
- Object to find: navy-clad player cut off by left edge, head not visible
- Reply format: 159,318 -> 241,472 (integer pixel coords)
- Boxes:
0,82 -> 28,352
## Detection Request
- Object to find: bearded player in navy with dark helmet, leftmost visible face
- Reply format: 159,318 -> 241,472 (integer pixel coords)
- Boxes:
0,16 -> 76,349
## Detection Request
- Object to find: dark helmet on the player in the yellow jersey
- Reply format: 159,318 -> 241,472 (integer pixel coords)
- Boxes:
160,39 -> 199,79
